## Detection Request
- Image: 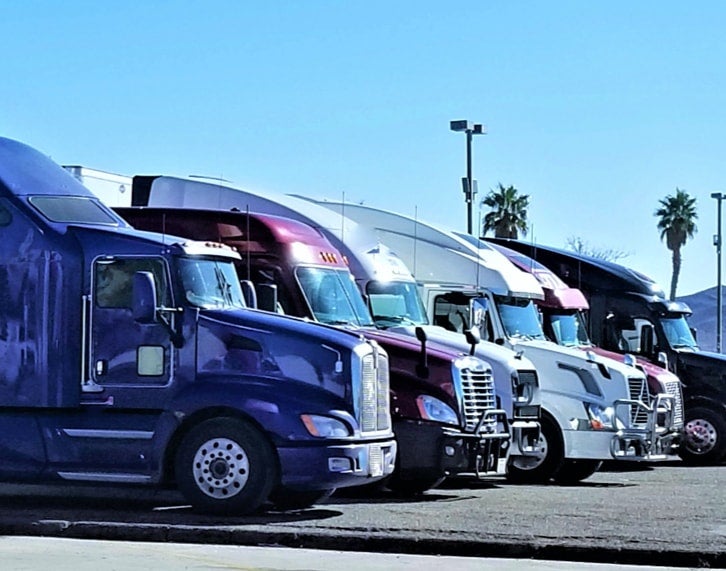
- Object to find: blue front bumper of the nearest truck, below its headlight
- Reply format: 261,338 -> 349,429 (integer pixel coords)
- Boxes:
278,440 -> 398,490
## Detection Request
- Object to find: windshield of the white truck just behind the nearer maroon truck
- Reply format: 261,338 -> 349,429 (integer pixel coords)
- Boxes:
366,281 -> 429,329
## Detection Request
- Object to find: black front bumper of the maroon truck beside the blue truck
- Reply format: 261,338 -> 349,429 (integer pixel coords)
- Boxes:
393,410 -> 511,480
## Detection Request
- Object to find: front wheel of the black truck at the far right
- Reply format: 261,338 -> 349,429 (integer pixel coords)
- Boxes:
678,406 -> 726,466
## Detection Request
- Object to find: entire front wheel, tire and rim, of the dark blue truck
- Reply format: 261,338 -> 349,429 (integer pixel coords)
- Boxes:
175,418 -> 278,515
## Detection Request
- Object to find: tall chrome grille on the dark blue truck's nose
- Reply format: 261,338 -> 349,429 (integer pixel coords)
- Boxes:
360,351 -> 391,432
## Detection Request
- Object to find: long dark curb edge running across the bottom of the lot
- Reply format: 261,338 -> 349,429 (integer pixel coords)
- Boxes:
0,520 -> 726,568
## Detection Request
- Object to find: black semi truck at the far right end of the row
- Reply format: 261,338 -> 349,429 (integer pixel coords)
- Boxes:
492,239 -> 726,464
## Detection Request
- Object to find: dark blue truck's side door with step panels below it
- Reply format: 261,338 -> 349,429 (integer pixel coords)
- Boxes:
48,258 -> 176,483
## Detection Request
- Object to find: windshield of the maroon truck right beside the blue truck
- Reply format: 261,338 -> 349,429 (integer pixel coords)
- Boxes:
295,266 -> 373,327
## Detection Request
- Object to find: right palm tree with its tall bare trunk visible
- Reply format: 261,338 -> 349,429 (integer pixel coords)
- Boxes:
655,188 -> 698,299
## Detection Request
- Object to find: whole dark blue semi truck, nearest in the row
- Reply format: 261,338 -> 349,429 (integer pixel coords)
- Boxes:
0,139 -> 396,515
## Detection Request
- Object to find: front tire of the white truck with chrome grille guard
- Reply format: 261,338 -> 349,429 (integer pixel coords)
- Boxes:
507,415 -> 565,484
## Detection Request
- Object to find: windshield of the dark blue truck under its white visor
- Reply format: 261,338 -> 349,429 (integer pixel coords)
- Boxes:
178,258 -> 245,309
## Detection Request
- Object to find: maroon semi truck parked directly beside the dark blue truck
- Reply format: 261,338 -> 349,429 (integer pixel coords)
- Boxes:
115,207 -> 510,493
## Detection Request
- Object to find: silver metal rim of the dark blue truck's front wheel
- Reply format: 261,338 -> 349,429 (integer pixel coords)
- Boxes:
192,438 -> 250,498
